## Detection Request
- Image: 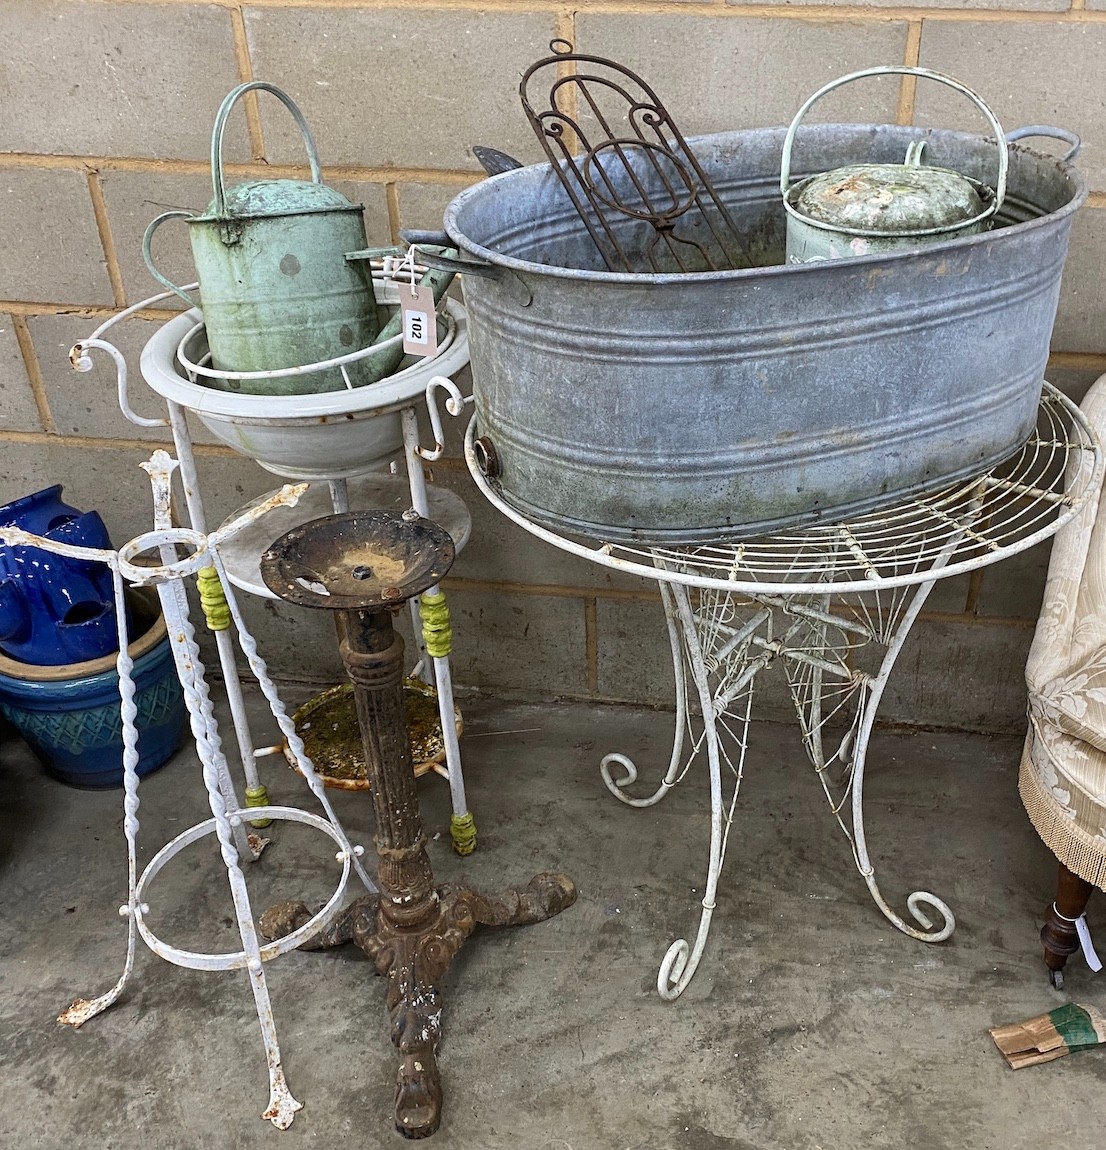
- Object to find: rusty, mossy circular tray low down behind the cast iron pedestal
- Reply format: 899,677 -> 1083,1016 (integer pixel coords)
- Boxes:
282,679 -> 464,790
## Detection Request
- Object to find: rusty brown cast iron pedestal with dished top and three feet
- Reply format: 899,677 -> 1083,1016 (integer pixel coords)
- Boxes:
254,512 -> 576,1139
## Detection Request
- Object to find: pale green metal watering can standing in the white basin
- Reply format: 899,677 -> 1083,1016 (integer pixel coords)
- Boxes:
143,81 -> 379,396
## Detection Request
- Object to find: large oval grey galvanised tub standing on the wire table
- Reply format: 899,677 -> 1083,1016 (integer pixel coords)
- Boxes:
436,124 -> 1086,544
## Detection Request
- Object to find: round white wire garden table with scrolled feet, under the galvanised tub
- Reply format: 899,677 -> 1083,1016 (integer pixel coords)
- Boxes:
452,381 -> 1103,999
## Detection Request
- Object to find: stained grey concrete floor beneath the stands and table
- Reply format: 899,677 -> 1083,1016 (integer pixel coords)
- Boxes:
0,700 -> 1106,1150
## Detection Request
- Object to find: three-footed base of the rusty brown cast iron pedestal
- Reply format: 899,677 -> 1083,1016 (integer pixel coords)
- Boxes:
260,874 -> 576,1139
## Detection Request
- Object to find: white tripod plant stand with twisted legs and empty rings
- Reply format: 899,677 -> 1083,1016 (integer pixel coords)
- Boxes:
0,451 -> 376,1129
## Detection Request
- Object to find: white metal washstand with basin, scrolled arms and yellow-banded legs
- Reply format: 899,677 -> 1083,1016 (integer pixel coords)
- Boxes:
71,258 -> 476,854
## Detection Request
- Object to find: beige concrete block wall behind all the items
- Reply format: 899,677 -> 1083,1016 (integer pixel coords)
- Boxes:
0,0 -> 1106,730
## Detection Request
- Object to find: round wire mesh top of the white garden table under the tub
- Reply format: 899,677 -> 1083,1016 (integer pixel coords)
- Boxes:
466,383 -> 1103,595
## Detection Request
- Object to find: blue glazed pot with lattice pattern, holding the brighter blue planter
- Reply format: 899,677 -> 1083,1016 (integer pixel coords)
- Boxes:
0,600 -> 186,788
